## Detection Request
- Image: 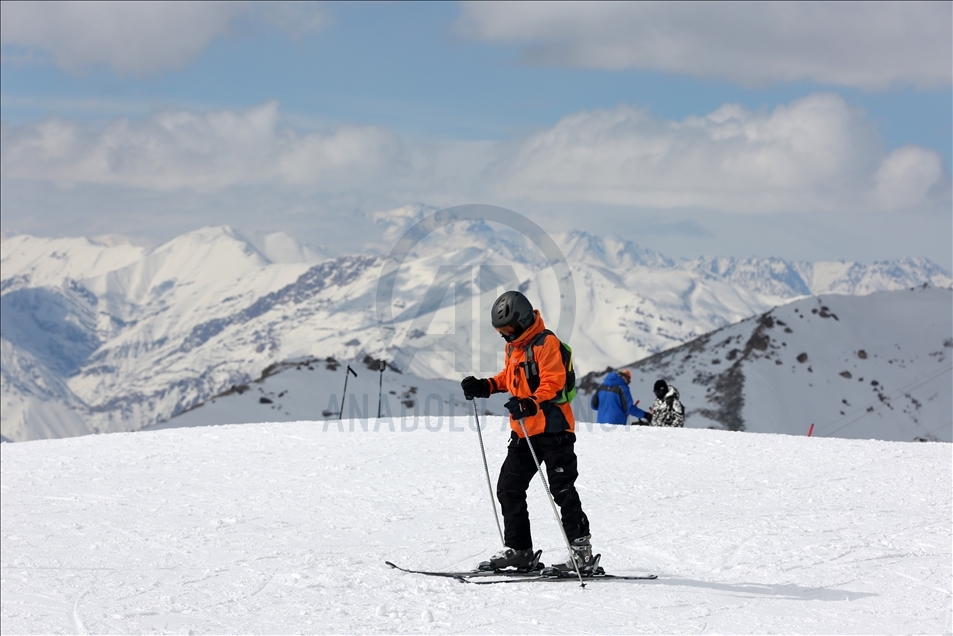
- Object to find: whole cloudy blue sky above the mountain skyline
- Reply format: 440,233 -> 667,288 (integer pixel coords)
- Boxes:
0,3 -> 953,268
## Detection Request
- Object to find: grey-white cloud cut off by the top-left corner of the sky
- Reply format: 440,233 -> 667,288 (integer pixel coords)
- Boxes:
0,2 -> 324,75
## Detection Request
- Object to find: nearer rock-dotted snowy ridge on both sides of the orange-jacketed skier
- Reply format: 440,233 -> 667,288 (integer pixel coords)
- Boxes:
160,288 -> 953,442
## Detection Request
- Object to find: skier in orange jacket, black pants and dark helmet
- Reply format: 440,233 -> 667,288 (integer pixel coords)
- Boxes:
460,291 -> 594,575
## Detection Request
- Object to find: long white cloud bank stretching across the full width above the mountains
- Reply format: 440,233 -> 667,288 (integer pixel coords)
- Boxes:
0,94 -> 950,214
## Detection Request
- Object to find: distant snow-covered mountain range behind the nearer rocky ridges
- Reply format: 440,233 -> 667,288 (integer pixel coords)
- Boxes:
0,221 -> 951,440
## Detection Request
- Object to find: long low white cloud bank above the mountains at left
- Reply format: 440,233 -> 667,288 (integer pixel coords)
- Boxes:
0,102 -> 403,191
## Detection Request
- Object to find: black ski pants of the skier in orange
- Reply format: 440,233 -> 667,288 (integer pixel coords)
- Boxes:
496,433 -> 589,550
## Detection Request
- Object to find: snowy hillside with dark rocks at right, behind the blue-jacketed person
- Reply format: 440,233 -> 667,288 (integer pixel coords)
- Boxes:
580,288 -> 953,442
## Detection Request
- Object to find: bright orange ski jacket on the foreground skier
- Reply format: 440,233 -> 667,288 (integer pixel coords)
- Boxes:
490,309 -> 576,437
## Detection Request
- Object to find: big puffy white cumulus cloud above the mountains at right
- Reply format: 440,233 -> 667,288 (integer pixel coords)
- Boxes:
491,94 -> 949,213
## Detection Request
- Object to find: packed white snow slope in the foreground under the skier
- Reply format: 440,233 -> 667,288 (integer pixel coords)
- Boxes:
0,416 -> 953,634
